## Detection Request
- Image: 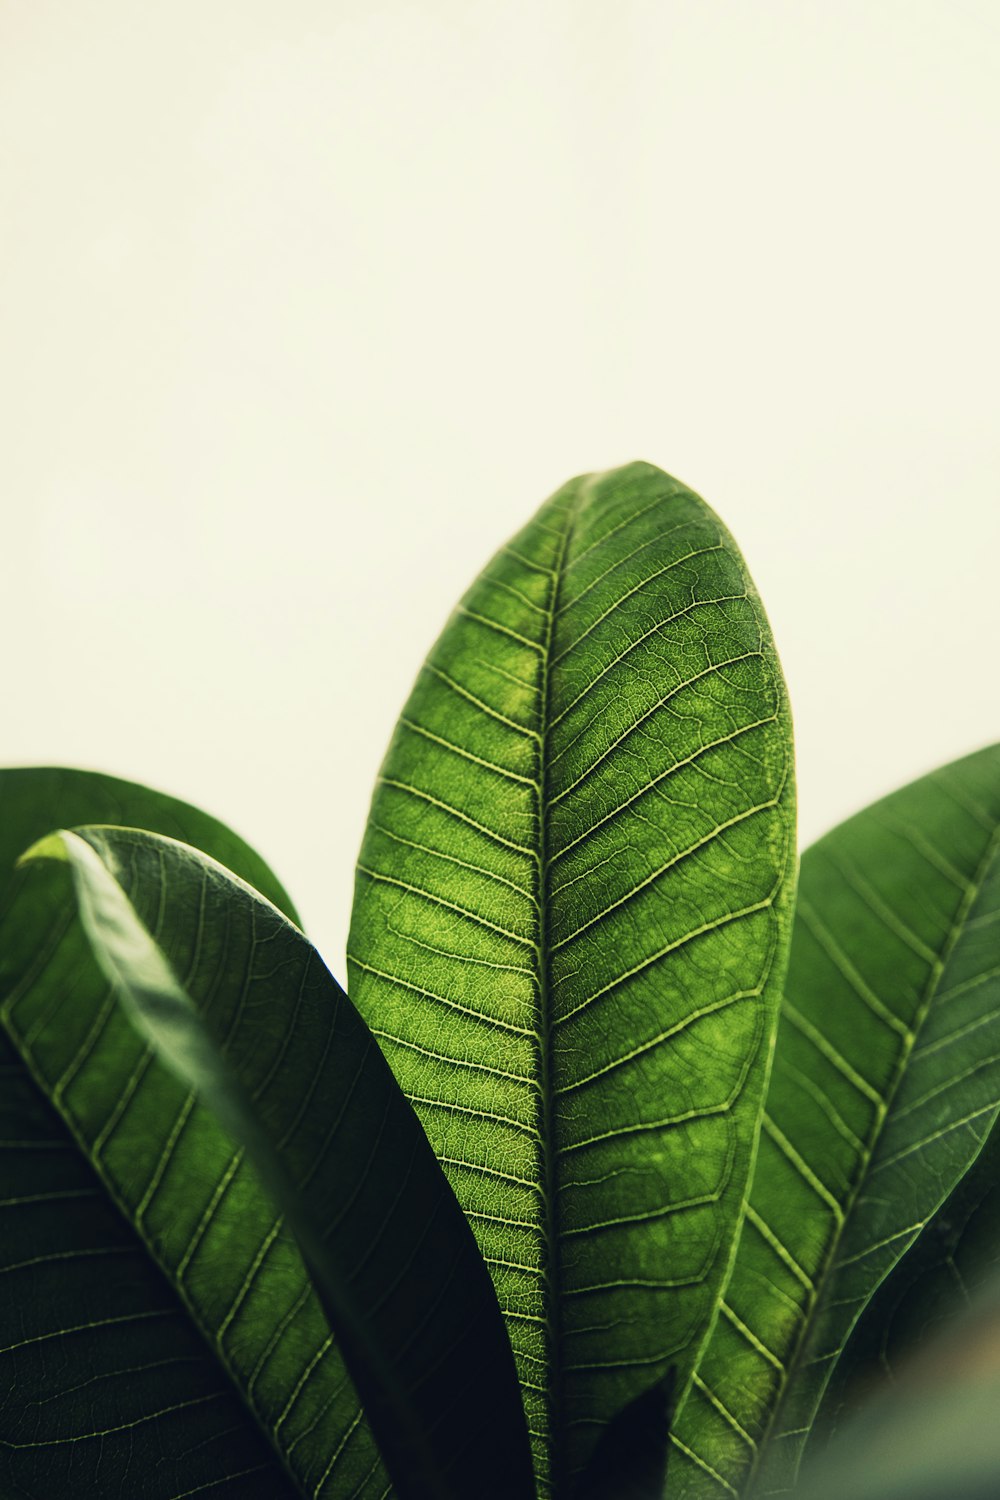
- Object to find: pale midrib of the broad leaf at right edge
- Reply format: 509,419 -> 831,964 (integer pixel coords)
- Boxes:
745,804 -> 1000,1494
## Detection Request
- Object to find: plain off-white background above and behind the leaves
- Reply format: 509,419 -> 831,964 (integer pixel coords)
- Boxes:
0,0 -> 1000,974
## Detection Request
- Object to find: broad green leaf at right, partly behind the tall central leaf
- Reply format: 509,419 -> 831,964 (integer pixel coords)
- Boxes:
670,747 -> 1000,1497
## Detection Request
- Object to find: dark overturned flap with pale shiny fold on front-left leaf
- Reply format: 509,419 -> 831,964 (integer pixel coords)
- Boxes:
43,830 -> 529,1500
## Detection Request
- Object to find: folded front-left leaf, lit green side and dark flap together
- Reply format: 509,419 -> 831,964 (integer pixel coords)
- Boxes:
4,780 -> 531,1497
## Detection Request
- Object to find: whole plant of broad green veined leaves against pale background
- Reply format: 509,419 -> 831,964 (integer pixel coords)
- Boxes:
0,464 -> 1000,1500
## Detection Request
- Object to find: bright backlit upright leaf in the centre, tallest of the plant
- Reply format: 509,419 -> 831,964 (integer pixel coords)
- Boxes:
348,464 -> 793,1496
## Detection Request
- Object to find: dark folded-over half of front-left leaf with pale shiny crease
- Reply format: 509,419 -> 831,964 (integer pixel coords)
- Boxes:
10,828 -> 531,1500
